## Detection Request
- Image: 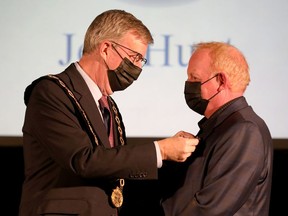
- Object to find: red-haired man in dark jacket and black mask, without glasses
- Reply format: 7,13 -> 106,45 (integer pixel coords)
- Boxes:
160,42 -> 273,216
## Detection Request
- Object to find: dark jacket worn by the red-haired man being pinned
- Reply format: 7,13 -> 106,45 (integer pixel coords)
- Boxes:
159,97 -> 273,216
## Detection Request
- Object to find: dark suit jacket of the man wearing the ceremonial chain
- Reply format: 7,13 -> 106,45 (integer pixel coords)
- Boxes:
19,64 -> 158,216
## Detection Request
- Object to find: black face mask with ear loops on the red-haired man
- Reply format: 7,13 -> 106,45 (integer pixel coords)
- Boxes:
184,74 -> 219,115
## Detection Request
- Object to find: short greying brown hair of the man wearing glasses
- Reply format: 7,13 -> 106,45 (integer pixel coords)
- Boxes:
83,9 -> 153,54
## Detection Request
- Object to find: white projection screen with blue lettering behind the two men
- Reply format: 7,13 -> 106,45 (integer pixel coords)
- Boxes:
0,0 -> 288,139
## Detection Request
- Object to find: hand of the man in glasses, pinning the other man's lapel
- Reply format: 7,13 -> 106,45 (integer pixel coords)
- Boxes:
157,131 -> 199,162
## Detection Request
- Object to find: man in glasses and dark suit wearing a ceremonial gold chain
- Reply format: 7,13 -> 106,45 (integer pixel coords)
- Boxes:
19,10 -> 198,216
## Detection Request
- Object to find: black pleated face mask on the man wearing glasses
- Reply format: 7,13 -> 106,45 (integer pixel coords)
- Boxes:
108,58 -> 142,92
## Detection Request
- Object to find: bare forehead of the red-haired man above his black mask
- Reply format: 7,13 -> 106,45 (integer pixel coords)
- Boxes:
187,49 -> 211,78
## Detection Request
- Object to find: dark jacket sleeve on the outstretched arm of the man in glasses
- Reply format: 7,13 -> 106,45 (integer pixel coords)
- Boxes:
23,80 -> 157,179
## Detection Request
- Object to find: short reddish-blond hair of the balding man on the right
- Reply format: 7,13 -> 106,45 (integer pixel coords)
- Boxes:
194,42 -> 250,92
